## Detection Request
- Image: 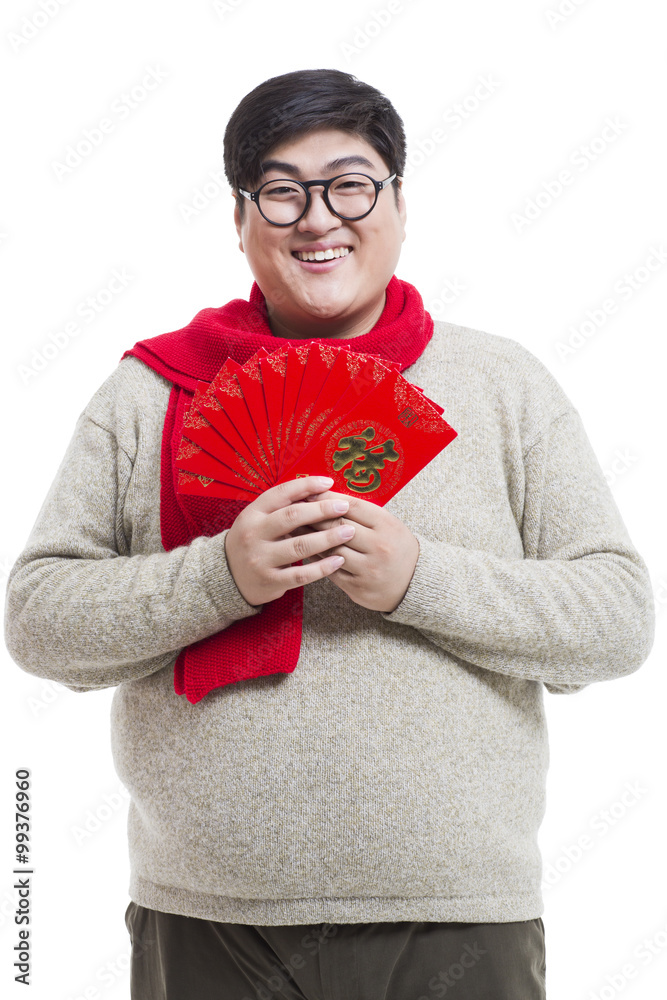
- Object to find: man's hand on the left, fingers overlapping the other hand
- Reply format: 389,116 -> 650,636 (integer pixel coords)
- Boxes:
225,476 -> 354,606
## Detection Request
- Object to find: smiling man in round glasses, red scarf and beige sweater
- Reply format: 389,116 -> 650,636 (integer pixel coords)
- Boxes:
6,70 -> 653,1000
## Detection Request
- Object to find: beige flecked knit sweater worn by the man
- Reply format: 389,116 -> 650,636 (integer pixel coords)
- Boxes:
5,322 -> 654,925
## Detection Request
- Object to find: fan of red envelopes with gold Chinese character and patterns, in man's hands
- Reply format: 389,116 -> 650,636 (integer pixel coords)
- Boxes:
176,343 -> 457,506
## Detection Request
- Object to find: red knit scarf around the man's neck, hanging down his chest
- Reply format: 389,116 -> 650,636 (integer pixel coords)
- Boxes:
121,275 -> 433,705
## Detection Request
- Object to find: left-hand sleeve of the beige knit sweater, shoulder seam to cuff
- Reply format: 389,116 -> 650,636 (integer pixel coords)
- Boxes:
5,411 -> 260,691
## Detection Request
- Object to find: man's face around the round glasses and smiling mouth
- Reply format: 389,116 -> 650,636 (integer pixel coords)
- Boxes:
234,129 -> 406,337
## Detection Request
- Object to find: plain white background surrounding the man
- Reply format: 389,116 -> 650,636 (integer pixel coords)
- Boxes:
0,0 -> 667,1000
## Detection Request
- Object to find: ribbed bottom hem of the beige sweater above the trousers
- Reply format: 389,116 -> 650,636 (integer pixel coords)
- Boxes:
129,875 -> 544,926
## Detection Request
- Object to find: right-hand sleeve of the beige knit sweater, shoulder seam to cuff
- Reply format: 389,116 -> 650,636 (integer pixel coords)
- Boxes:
383,409 -> 655,693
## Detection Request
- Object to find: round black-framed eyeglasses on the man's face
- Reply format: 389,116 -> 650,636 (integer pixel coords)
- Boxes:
239,174 -> 396,226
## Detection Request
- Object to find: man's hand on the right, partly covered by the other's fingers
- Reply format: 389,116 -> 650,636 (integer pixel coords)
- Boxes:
297,491 -> 419,614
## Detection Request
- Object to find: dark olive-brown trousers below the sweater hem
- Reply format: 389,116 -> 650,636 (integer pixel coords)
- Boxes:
125,902 -> 546,1000
